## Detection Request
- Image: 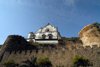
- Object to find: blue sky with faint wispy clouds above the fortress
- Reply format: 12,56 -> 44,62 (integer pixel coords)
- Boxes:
0,0 -> 100,44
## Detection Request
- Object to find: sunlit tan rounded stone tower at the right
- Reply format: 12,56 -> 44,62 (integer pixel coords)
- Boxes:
79,24 -> 100,47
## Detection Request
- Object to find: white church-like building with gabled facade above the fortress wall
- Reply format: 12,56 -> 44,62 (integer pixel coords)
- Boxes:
27,23 -> 61,43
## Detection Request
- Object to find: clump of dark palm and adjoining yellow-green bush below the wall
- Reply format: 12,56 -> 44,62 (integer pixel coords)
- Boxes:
20,56 -> 52,67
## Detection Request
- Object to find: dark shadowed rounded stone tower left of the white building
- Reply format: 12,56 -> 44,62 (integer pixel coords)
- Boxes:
4,35 -> 36,51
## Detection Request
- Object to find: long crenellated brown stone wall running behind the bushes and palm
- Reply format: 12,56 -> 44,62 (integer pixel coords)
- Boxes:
0,46 -> 100,67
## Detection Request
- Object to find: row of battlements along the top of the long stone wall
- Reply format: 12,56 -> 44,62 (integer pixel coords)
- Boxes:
6,45 -> 100,55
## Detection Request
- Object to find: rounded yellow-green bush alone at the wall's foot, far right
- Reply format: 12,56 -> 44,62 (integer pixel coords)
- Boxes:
73,55 -> 93,67
